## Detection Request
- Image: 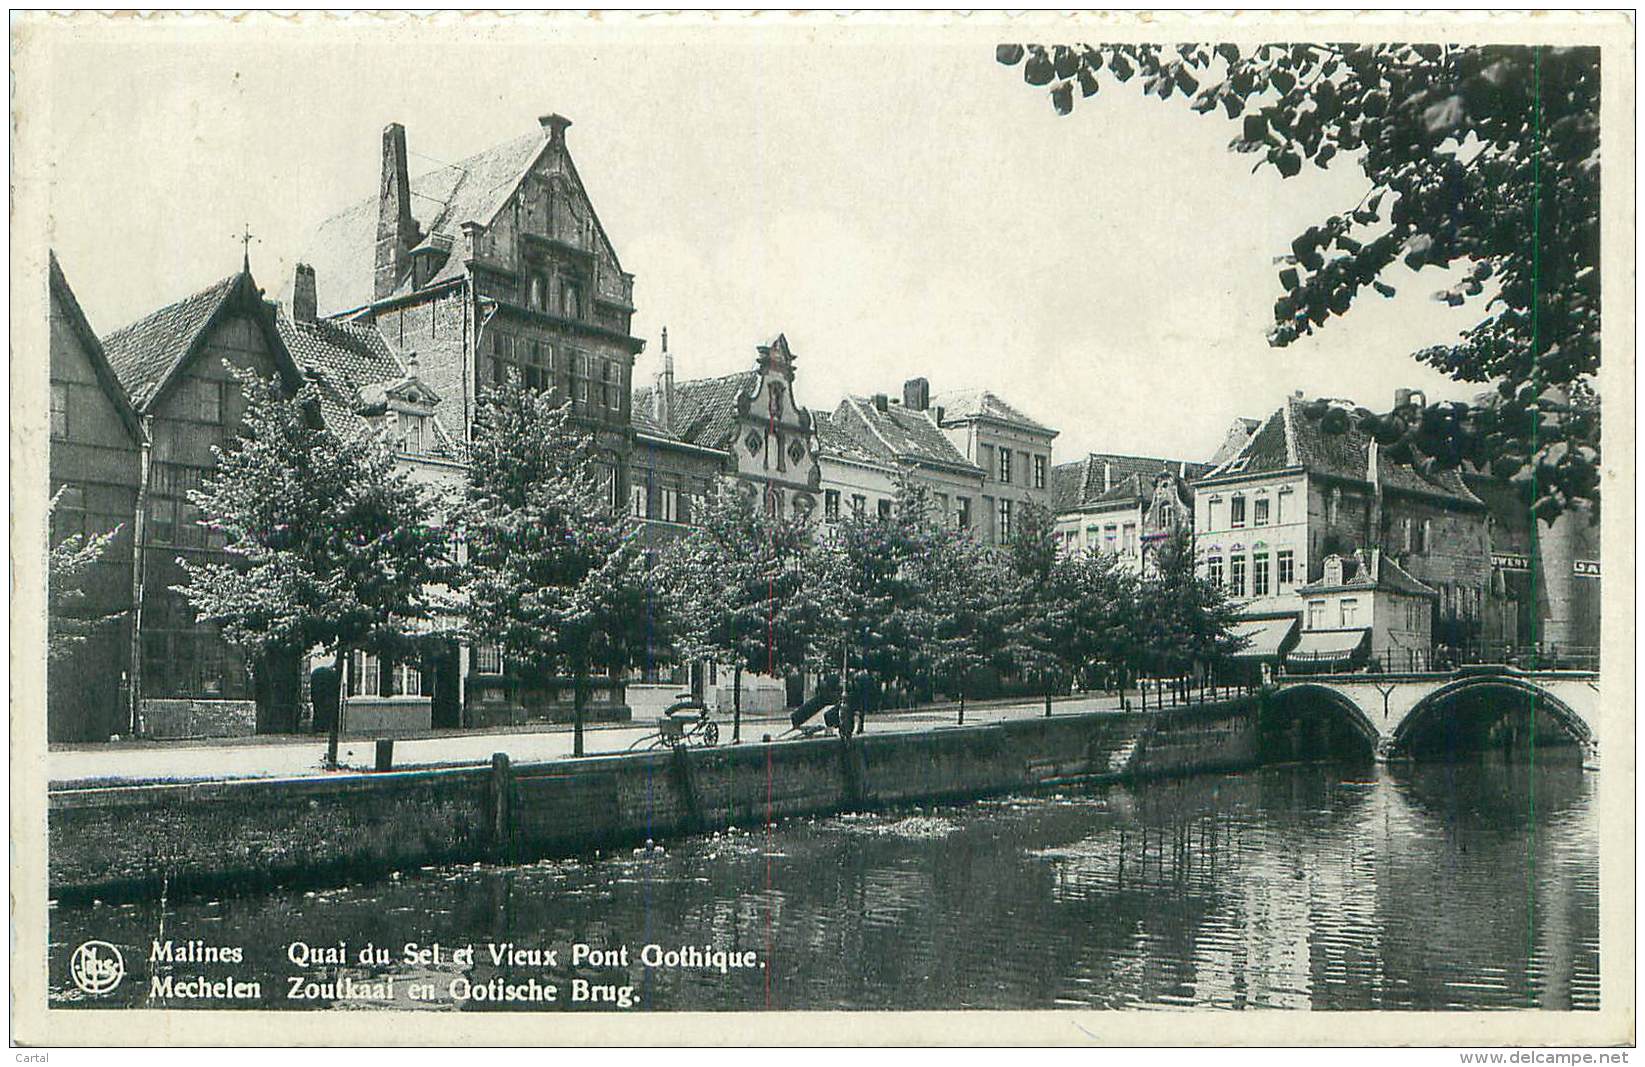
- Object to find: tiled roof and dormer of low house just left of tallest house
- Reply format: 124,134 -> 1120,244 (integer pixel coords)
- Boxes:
278,307 -> 461,459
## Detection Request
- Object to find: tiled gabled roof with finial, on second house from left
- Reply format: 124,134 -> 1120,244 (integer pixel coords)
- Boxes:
104,270 -> 303,413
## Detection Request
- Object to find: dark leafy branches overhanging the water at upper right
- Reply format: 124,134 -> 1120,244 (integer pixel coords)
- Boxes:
995,44 -> 1601,521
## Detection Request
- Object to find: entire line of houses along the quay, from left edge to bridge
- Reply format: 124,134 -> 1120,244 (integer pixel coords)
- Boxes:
48,115 -> 1597,741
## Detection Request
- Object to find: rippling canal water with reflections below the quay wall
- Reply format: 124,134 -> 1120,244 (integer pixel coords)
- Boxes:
51,761 -> 1599,1011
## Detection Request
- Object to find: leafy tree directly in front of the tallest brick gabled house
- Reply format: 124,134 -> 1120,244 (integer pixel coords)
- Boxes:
459,385 -> 671,756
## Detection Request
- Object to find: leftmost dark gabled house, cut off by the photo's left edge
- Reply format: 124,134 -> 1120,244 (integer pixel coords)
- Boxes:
46,253 -> 146,741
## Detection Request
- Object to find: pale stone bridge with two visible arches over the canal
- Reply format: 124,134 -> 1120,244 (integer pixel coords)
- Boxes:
1273,666 -> 1601,769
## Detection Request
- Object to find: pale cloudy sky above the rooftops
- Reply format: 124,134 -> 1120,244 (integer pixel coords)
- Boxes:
44,16 -> 1479,462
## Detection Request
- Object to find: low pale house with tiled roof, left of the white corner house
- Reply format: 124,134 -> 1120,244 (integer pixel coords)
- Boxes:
1051,452 -> 1211,570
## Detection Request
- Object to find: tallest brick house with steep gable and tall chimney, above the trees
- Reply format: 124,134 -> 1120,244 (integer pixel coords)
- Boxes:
293,115 -> 643,500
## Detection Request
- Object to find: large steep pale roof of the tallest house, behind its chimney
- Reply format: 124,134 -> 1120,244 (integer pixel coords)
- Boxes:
301,130 -> 548,316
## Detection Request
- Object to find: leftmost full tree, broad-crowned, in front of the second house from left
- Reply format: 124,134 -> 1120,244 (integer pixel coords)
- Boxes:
178,372 -> 449,766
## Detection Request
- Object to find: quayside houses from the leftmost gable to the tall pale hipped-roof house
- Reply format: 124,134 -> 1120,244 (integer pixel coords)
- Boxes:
48,115 -> 1056,741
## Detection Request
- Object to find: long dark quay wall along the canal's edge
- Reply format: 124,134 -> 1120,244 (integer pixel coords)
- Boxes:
48,697 -> 1258,899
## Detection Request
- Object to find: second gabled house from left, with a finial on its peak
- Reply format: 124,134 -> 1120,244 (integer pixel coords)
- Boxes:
101,266 -> 303,737
